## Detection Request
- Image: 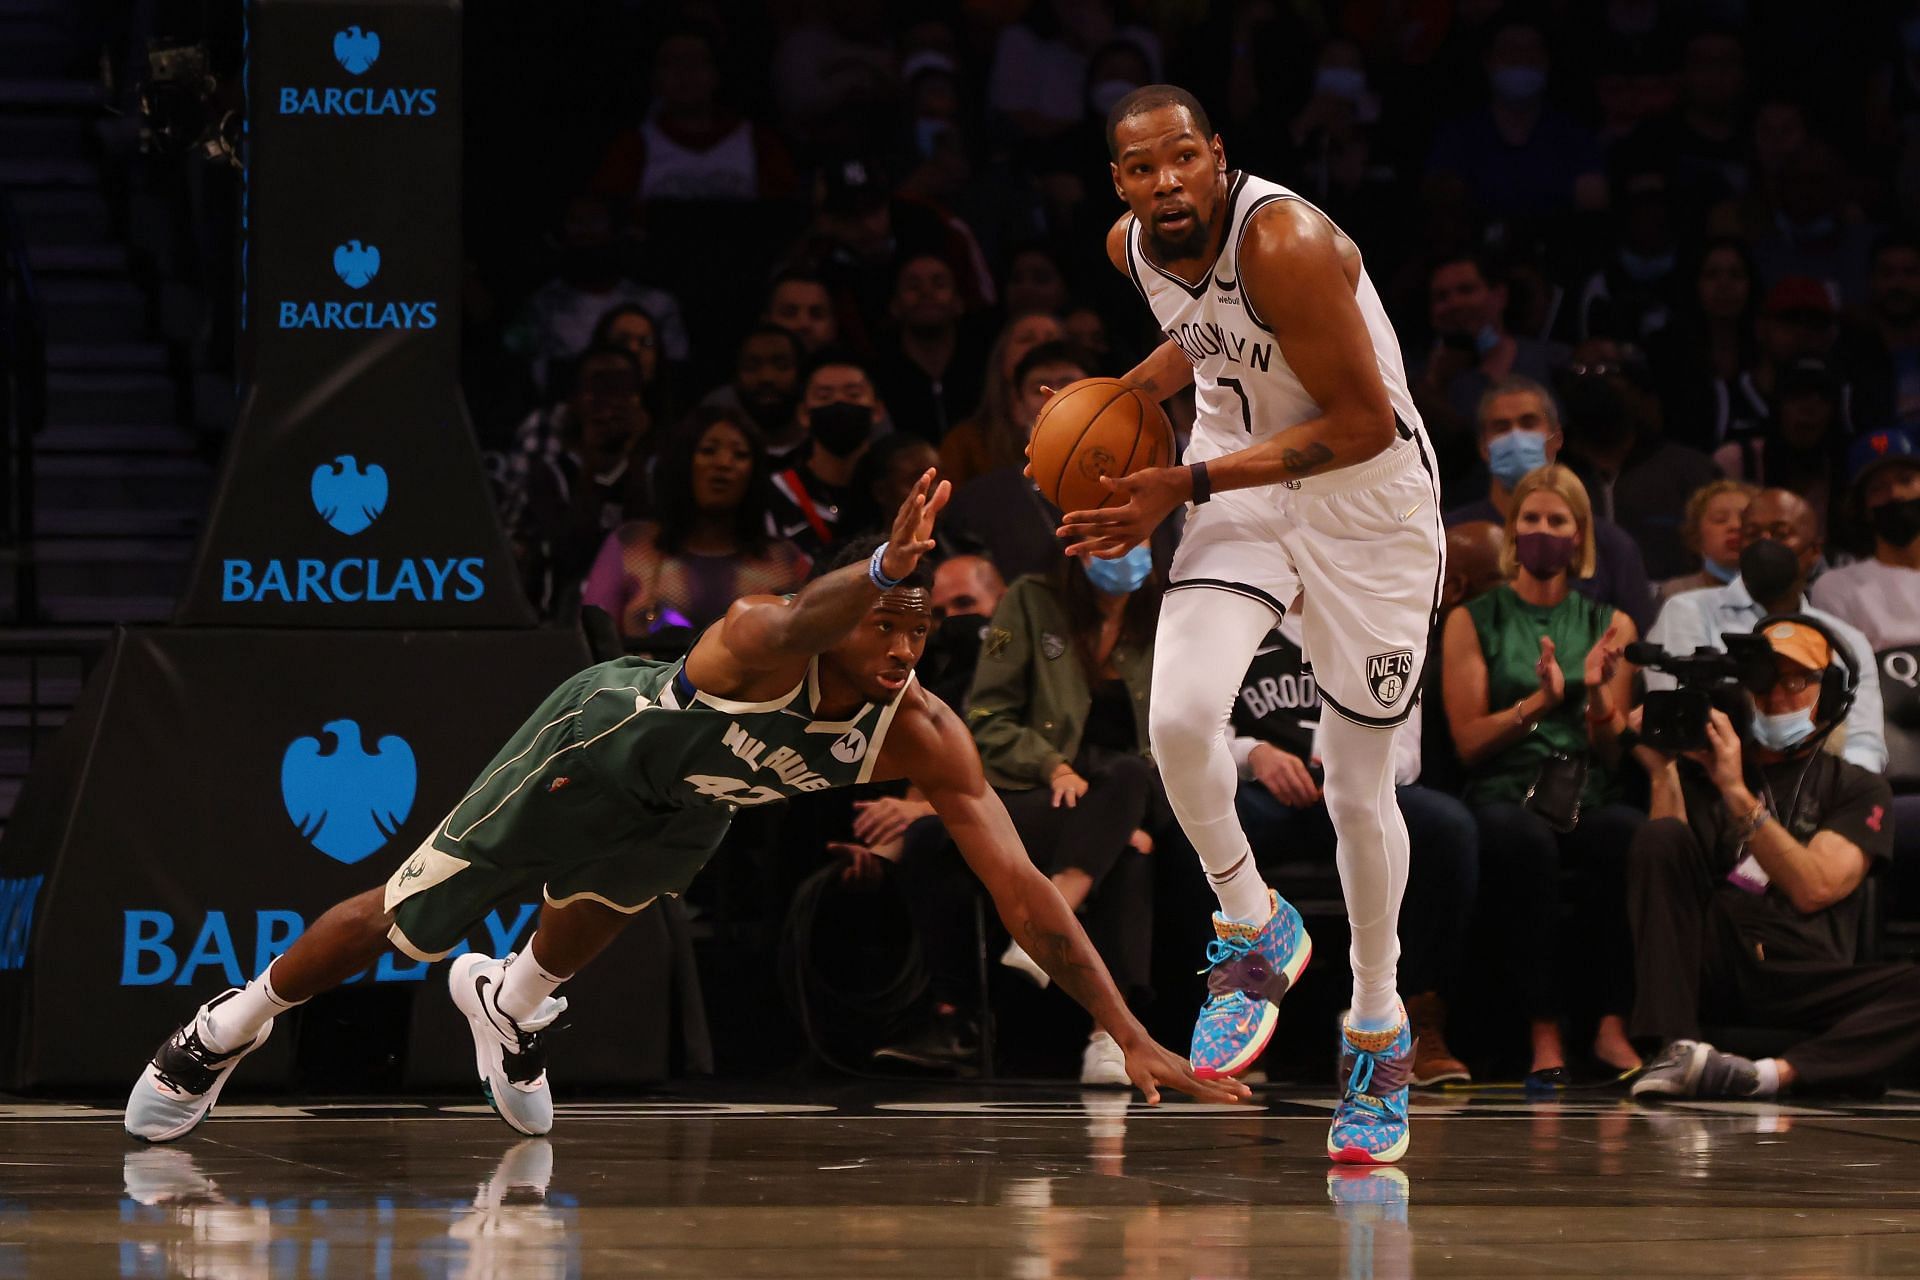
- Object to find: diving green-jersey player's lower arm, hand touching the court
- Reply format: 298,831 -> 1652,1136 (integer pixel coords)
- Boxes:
887,691 -> 1250,1103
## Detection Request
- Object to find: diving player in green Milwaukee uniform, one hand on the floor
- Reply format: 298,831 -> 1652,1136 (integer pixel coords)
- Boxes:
127,472 -> 1248,1142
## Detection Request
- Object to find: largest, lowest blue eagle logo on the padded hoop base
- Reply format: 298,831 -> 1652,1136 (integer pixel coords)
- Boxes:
280,720 -> 419,865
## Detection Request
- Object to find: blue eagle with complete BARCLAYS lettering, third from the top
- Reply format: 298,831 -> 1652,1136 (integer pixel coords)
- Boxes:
221,453 -> 486,604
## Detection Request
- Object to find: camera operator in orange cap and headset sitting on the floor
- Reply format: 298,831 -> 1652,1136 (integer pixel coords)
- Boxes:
1628,616 -> 1920,1098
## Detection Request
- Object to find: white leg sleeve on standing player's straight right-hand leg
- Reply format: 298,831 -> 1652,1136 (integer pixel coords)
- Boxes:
1319,708 -> 1407,1027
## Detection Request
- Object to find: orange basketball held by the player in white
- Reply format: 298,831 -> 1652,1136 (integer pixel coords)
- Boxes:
1027,378 -> 1173,510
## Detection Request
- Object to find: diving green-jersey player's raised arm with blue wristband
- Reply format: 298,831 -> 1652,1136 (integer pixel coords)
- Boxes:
706,470 -> 952,671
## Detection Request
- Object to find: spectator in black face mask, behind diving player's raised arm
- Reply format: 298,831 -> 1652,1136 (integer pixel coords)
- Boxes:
774,351 -> 885,560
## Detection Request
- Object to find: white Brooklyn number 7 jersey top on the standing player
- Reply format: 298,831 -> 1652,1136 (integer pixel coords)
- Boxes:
1127,171 -> 1425,462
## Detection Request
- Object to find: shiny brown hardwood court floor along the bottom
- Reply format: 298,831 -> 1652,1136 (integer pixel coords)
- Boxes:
0,1084 -> 1920,1280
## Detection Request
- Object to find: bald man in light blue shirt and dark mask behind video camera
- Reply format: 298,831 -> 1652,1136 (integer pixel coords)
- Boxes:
1645,489 -> 1887,773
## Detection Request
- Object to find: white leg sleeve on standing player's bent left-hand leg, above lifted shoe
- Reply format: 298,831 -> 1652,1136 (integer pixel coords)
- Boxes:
1150,587 -> 1277,921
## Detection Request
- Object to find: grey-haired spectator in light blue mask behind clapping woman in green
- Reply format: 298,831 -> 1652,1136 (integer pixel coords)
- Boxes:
1446,374 -> 1653,640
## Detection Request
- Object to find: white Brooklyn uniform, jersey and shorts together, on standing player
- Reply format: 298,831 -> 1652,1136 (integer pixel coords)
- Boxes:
1127,173 -> 1444,727
